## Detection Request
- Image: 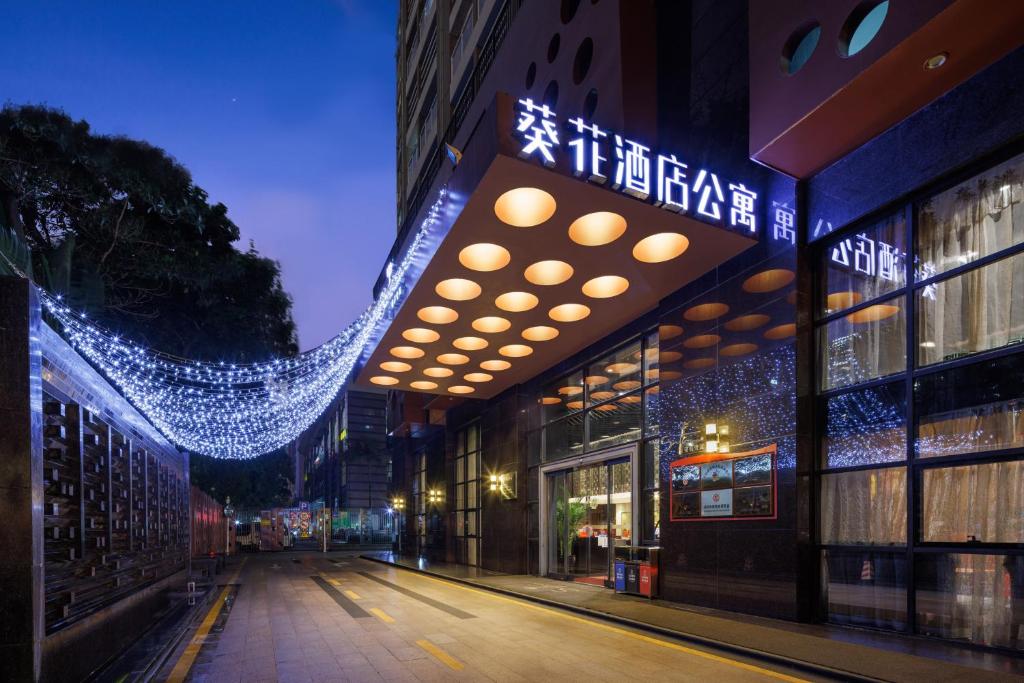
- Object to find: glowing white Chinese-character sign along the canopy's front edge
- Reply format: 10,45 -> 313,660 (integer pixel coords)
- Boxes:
516,98 -> 758,232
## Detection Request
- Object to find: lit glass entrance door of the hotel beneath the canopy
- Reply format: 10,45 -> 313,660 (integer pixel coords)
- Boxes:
546,458 -> 633,586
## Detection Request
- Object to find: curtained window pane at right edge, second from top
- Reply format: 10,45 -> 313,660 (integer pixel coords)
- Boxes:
916,252 -> 1024,366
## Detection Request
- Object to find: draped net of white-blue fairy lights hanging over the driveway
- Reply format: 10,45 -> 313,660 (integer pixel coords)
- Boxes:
30,188 -> 447,459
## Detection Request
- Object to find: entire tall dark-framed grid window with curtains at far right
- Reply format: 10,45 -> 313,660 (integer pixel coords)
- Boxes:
815,149 -> 1024,649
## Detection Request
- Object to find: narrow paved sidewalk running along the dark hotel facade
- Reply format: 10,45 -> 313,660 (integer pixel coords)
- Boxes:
361,552 -> 1024,683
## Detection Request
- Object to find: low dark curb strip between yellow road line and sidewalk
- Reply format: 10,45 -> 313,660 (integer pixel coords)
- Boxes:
359,555 -> 886,683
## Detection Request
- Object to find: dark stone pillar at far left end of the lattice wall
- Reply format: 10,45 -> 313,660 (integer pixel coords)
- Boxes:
0,278 -> 44,681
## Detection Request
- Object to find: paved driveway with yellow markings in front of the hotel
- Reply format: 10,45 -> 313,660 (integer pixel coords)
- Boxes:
165,552 -> 823,683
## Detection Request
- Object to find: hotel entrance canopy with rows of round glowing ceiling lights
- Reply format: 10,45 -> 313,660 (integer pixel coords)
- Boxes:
356,96 -> 757,398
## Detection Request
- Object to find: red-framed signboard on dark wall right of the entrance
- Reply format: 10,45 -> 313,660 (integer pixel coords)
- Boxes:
669,443 -> 778,522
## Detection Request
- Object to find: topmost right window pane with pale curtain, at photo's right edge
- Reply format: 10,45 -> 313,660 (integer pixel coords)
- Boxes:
914,156 -> 1024,281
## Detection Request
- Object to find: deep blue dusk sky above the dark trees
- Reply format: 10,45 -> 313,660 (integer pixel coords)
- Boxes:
0,0 -> 397,349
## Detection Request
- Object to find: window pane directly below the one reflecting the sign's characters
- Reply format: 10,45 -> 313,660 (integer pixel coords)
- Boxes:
818,297 -> 906,390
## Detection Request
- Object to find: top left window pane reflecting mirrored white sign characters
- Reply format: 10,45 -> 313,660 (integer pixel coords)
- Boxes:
818,213 -> 906,314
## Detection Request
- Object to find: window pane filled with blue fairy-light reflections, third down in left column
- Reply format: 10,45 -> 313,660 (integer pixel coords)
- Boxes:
821,384 -> 906,467
